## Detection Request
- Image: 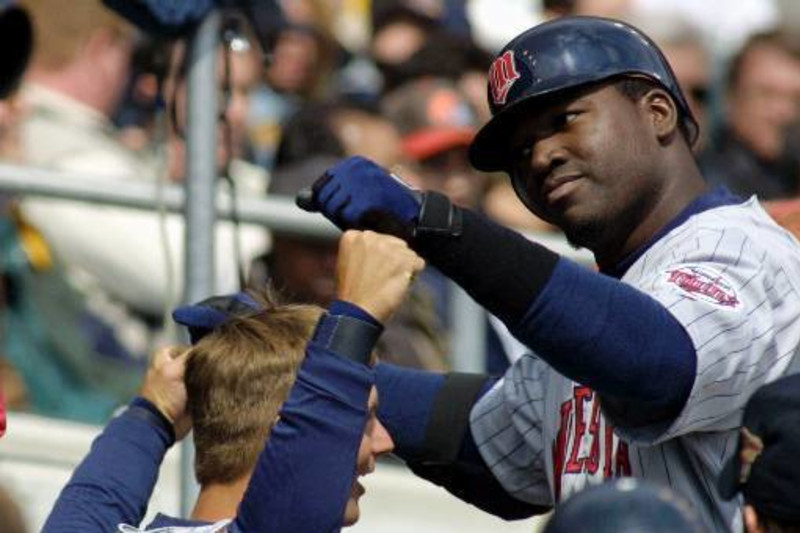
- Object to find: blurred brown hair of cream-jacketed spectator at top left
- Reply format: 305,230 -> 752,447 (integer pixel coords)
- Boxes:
20,0 -> 135,69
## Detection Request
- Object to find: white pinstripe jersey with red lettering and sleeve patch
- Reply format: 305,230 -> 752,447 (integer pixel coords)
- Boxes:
470,198 -> 800,531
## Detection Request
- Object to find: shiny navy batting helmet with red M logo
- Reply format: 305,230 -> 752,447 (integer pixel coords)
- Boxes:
469,17 -> 698,171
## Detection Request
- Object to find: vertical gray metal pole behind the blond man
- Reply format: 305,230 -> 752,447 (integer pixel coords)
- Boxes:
181,11 -> 220,516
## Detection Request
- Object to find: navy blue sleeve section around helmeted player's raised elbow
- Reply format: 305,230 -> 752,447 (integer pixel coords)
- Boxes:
510,258 -> 697,407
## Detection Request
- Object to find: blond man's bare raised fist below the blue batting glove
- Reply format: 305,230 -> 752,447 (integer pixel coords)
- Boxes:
337,230 -> 425,324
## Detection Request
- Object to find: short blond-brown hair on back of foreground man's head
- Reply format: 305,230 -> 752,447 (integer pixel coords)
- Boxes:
184,297 -> 323,485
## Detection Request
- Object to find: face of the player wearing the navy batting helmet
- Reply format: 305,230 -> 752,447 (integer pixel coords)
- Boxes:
512,85 -> 660,252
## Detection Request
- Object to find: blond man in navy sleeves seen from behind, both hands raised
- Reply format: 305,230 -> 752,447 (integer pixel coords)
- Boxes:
44,232 -> 424,533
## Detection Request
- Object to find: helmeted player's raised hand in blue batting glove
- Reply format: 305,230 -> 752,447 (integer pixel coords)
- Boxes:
297,156 -> 422,240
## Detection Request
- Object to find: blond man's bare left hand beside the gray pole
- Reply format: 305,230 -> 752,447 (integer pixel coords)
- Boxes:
141,346 -> 192,440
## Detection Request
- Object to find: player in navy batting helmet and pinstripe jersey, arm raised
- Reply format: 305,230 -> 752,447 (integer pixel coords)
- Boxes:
298,17 -> 800,531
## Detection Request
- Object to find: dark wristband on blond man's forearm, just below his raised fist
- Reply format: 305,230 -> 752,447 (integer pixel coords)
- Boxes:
311,313 -> 383,365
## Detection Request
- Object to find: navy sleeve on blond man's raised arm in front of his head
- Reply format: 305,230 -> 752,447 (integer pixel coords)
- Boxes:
232,313 -> 380,533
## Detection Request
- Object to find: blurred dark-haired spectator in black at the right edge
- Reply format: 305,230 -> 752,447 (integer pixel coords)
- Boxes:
700,32 -> 800,200
